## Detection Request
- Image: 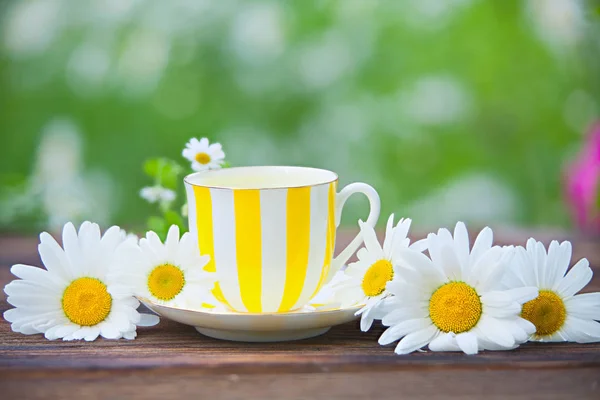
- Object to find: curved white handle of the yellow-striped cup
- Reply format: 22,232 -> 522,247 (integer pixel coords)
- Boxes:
325,183 -> 381,283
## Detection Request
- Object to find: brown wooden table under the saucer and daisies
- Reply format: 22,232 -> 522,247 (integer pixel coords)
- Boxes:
0,231 -> 600,400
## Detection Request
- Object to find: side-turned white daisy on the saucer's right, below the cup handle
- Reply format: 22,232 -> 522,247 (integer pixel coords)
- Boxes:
335,214 -> 424,332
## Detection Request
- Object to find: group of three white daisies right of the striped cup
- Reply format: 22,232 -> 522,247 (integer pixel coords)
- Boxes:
334,215 -> 600,354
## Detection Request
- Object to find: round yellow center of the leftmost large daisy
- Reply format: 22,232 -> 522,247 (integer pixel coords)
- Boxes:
62,277 -> 112,326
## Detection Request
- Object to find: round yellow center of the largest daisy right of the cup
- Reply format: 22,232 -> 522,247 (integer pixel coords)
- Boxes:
429,282 -> 482,333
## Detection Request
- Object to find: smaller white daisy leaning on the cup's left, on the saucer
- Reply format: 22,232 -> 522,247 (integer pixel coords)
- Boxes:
120,225 -> 218,309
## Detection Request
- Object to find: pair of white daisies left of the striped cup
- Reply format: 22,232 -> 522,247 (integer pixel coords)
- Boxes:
4,222 -> 218,341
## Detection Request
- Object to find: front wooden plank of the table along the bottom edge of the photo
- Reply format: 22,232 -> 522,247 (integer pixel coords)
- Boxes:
3,368 -> 600,400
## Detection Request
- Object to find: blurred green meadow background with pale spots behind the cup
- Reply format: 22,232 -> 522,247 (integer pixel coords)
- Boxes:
0,0 -> 600,231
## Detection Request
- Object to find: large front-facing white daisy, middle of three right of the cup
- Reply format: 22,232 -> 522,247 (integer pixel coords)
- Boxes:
379,222 -> 538,354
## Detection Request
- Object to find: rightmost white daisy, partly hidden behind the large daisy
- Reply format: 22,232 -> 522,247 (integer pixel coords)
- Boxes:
505,239 -> 600,343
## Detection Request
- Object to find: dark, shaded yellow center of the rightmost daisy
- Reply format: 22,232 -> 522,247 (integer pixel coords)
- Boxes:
521,290 -> 567,336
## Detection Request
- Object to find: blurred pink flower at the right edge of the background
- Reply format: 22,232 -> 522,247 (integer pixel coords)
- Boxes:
566,123 -> 600,233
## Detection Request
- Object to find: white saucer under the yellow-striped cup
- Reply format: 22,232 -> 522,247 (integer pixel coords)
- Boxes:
138,297 -> 361,342
